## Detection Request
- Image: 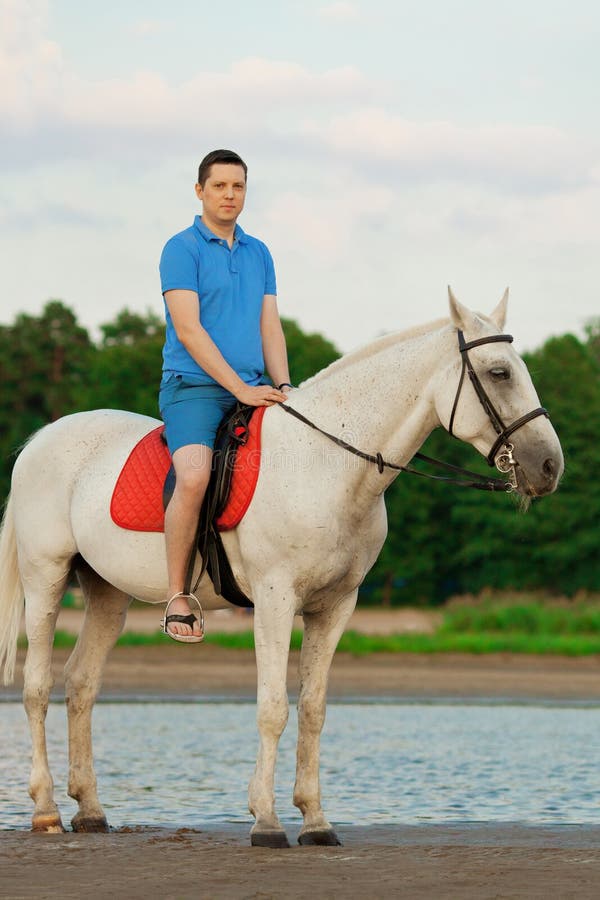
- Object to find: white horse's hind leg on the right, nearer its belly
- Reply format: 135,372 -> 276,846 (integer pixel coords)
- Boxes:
65,567 -> 131,831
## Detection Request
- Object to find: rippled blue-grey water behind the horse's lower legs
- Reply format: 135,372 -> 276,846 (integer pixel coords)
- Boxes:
0,702 -> 600,829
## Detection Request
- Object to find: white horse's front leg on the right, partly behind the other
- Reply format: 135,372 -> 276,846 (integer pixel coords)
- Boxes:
294,591 -> 357,845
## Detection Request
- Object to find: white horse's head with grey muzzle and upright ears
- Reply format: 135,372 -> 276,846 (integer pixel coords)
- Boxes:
436,289 -> 563,497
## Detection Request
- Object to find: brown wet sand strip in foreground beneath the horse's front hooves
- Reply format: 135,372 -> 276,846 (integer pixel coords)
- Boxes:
0,824 -> 600,900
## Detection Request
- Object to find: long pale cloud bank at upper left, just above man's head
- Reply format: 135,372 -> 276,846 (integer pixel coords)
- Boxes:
0,15 -> 373,168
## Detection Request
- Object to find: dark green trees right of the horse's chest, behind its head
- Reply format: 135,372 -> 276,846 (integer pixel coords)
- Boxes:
361,326 -> 600,604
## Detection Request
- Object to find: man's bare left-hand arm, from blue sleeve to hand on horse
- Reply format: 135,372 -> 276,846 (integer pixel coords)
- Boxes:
165,290 -> 285,406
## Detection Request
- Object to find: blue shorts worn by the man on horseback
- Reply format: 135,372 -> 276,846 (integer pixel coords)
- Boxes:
158,372 -> 237,455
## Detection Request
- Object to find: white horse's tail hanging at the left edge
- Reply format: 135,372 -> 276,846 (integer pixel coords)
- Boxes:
0,496 -> 24,684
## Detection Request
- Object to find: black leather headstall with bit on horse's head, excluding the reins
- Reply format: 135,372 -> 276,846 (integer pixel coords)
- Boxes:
448,329 -> 548,473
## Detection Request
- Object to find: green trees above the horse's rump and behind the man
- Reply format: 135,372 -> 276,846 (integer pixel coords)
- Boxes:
0,300 -> 339,497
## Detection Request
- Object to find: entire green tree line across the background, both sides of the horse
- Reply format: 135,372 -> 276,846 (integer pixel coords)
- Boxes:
0,300 -> 600,604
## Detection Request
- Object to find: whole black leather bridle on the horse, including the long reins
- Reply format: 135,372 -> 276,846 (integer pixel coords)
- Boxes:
277,329 -> 548,493
